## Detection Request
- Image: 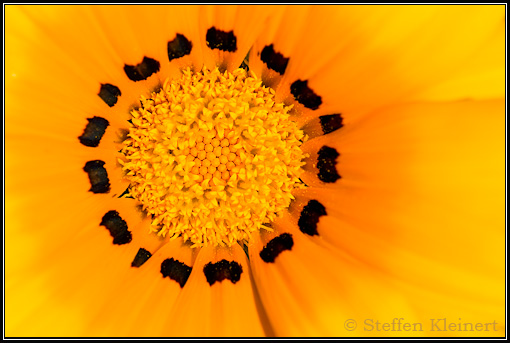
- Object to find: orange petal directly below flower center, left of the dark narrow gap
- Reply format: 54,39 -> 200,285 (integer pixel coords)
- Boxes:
163,245 -> 268,337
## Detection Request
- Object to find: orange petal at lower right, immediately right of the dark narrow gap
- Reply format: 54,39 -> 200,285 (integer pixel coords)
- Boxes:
249,215 -> 415,337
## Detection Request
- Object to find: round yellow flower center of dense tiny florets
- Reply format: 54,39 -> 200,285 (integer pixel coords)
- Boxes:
119,69 -> 306,246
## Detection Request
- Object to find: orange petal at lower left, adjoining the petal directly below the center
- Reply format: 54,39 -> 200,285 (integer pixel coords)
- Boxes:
85,235 -> 200,337
